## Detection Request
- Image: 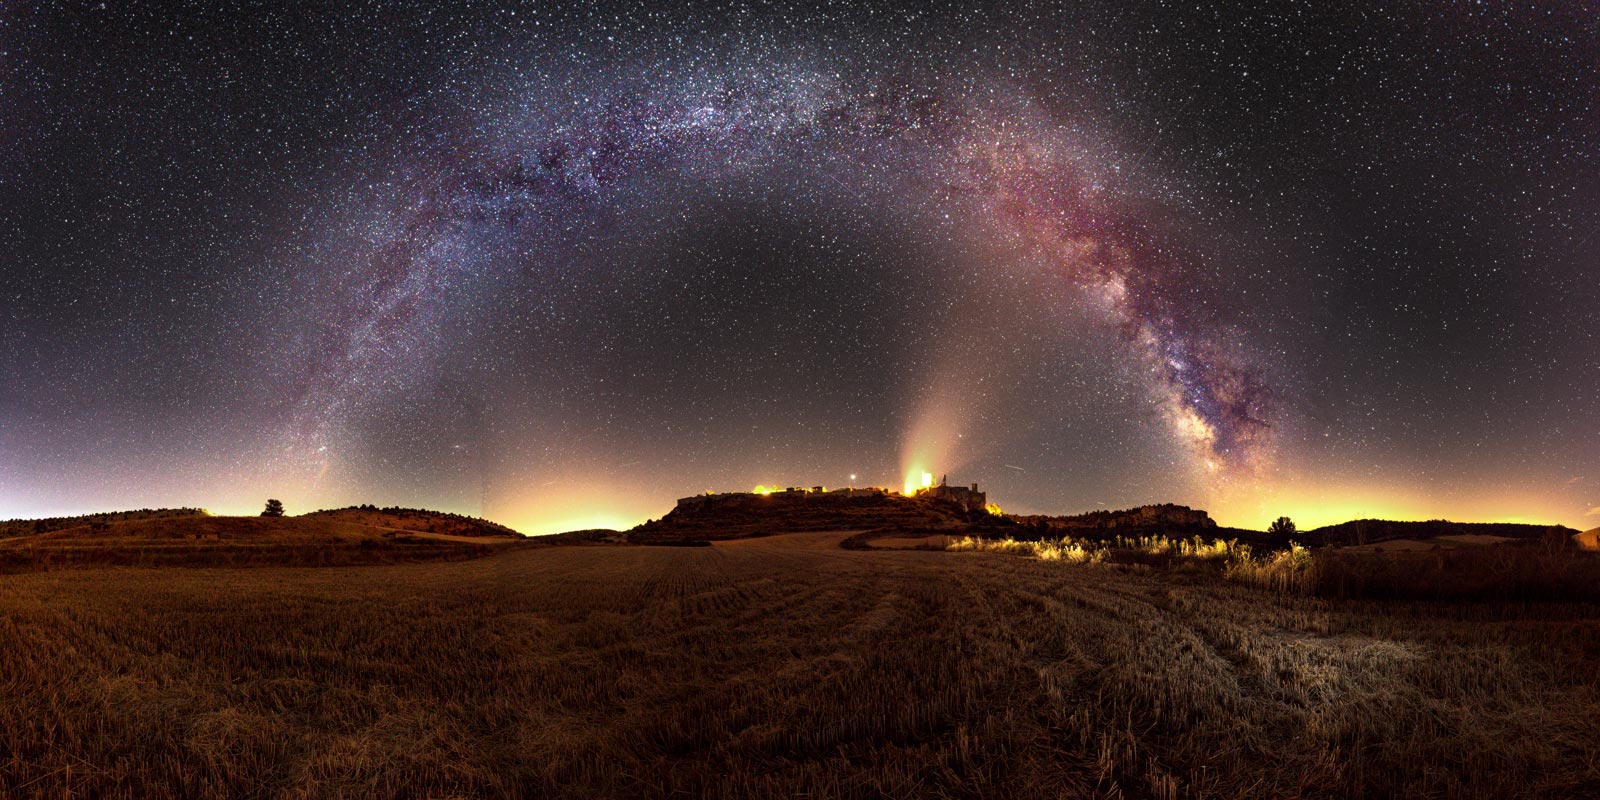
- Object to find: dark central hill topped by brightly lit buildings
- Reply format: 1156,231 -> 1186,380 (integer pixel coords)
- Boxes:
627,490 -> 972,544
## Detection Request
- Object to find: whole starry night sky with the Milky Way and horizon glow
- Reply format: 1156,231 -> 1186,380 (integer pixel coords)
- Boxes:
0,2 -> 1600,533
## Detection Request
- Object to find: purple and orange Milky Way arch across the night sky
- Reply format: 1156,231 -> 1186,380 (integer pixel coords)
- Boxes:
281,58 -> 1270,475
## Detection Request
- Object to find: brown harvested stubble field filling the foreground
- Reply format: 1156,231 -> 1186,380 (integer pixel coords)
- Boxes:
0,533 -> 1600,798
